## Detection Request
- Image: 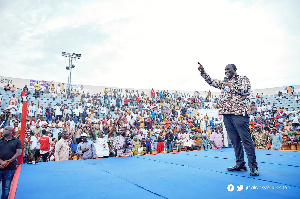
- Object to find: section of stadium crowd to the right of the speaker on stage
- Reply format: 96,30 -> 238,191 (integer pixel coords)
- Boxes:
249,92 -> 300,150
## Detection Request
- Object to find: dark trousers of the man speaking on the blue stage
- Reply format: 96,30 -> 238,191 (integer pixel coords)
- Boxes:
223,115 -> 257,168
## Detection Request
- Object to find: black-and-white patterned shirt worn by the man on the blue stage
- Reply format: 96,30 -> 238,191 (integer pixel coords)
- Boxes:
201,72 -> 251,116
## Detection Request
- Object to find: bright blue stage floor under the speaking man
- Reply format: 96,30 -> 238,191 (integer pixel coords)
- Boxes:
15,149 -> 300,199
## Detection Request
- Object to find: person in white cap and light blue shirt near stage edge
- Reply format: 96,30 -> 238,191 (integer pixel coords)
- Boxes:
76,133 -> 97,160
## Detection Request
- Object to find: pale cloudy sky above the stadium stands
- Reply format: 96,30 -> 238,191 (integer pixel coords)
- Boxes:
0,0 -> 300,91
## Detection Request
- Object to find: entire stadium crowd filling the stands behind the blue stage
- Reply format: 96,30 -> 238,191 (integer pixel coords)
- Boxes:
0,83 -> 300,163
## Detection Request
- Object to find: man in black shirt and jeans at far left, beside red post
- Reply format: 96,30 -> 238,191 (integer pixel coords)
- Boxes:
0,126 -> 22,199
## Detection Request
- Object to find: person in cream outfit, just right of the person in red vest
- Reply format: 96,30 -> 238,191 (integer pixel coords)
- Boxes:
54,131 -> 70,161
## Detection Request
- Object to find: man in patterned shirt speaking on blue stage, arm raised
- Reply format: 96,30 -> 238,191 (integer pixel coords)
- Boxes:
198,62 -> 259,176
